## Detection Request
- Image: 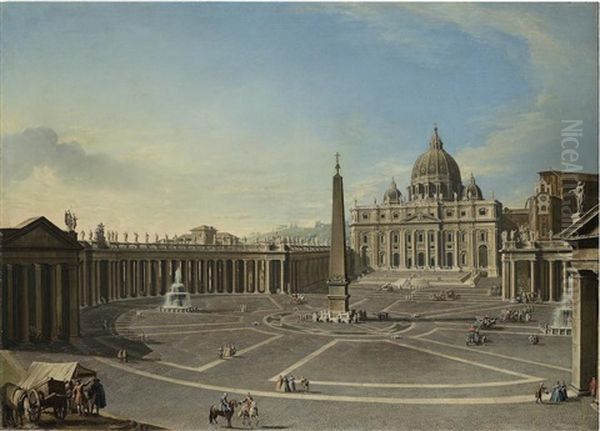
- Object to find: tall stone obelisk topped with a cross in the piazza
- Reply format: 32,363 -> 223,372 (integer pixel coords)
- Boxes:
327,153 -> 350,315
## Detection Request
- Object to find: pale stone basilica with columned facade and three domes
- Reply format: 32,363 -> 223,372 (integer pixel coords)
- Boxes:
350,127 -> 502,277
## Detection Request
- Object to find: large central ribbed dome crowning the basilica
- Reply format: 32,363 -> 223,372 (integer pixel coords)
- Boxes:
411,127 -> 462,198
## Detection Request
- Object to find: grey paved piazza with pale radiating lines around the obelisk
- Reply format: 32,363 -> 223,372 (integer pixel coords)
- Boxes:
5,284 -> 597,430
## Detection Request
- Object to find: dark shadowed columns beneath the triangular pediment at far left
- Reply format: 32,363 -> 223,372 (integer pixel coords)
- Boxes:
2,263 -> 79,343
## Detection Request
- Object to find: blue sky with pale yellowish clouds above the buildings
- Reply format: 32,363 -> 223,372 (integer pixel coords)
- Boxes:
0,3 -> 598,236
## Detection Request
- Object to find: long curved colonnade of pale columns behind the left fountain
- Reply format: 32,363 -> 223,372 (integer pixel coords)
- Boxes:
79,253 -> 328,306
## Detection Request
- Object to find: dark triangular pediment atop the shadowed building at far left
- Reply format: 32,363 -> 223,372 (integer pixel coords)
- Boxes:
2,217 -> 81,250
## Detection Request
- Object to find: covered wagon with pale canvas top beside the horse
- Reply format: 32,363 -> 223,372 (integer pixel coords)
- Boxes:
19,362 -> 96,422
